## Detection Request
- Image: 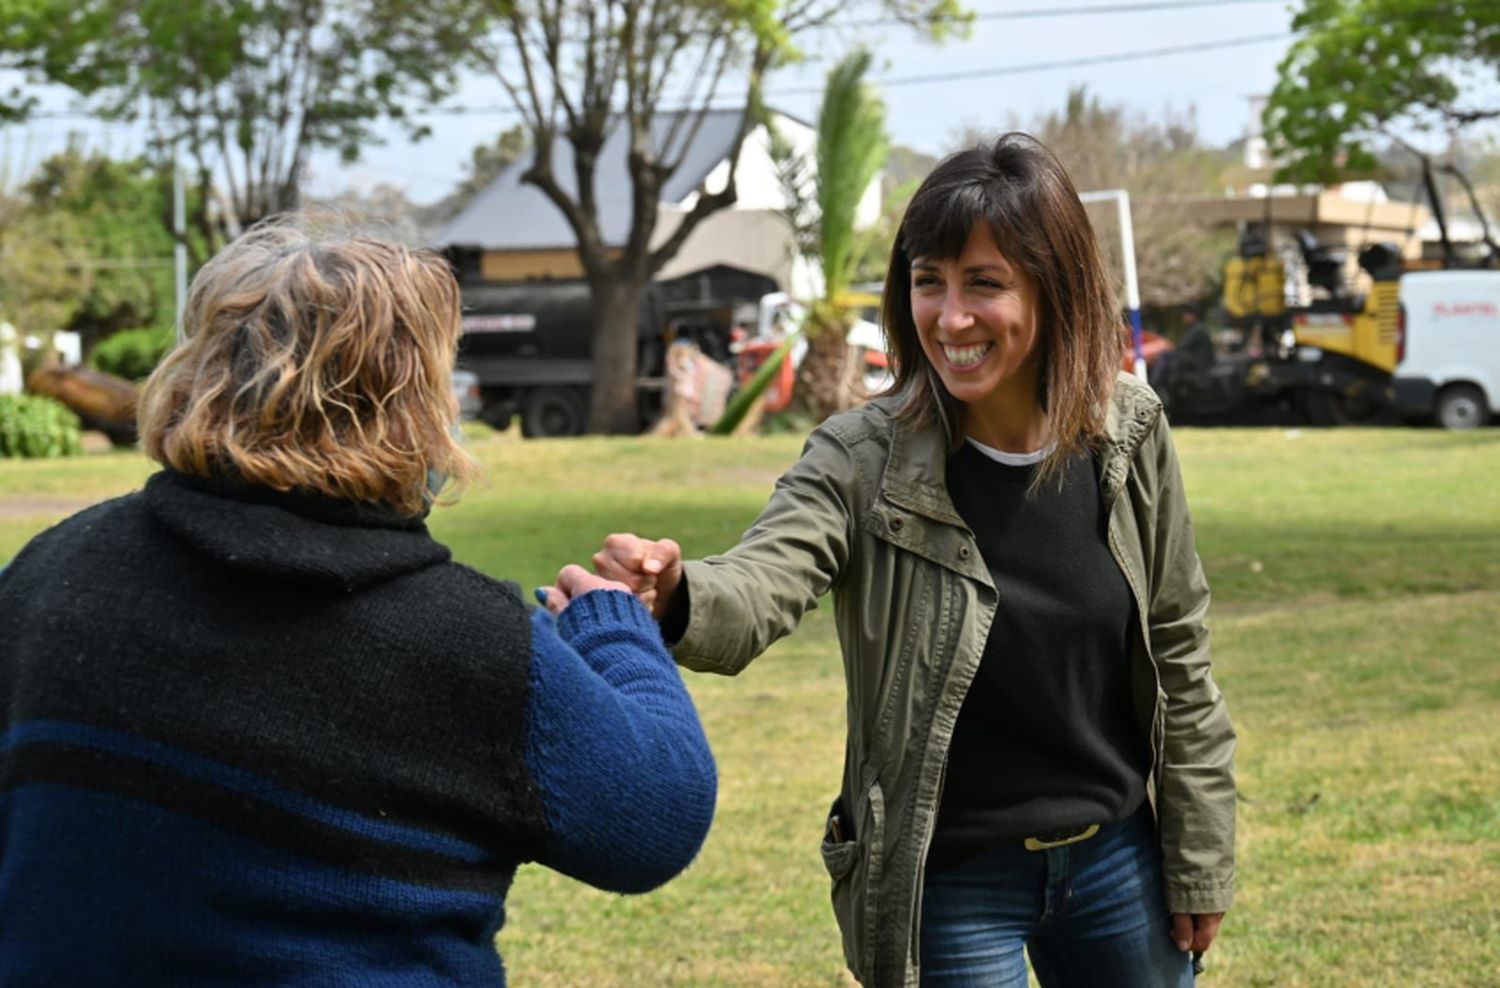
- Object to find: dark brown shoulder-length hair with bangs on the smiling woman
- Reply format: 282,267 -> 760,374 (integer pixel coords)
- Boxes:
881,133 -> 1121,490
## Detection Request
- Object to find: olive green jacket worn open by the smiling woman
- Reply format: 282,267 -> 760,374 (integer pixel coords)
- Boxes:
674,375 -> 1235,985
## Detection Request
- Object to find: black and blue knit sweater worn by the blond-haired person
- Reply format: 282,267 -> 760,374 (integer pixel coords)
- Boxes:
0,474 -> 716,988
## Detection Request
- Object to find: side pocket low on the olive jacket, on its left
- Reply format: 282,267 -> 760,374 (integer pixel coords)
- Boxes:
822,783 -> 885,984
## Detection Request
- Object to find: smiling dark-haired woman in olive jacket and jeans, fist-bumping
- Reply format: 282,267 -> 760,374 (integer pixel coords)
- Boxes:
594,133 -> 1235,988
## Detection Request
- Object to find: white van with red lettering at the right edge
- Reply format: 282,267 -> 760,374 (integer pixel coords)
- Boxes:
1395,271 -> 1500,429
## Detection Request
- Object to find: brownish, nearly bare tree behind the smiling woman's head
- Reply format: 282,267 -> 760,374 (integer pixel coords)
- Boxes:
1008,87 -> 1232,313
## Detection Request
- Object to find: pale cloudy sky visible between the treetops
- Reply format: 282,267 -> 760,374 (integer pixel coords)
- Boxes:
0,0 -> 1292,202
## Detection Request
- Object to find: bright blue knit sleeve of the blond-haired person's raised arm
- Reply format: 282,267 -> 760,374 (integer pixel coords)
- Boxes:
525,591 -> 717,892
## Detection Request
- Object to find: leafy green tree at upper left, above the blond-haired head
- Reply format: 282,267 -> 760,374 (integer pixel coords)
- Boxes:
0,0 -> 468,259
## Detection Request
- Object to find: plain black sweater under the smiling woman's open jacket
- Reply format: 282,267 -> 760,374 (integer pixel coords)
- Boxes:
927,444 -> 1149,871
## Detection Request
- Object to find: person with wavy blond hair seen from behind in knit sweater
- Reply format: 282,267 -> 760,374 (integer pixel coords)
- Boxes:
0,223 -> 716,988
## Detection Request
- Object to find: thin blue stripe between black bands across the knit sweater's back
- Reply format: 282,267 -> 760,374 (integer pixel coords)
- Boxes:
0,720 -> 489,862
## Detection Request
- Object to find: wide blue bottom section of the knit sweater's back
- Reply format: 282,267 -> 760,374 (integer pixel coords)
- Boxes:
0,784 -> 510,988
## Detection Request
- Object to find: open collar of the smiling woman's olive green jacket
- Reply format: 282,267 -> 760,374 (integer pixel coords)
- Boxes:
870,373 -> 1161,526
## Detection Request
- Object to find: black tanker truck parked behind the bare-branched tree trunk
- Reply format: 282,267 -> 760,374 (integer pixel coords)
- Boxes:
459,265 -> 777,436
